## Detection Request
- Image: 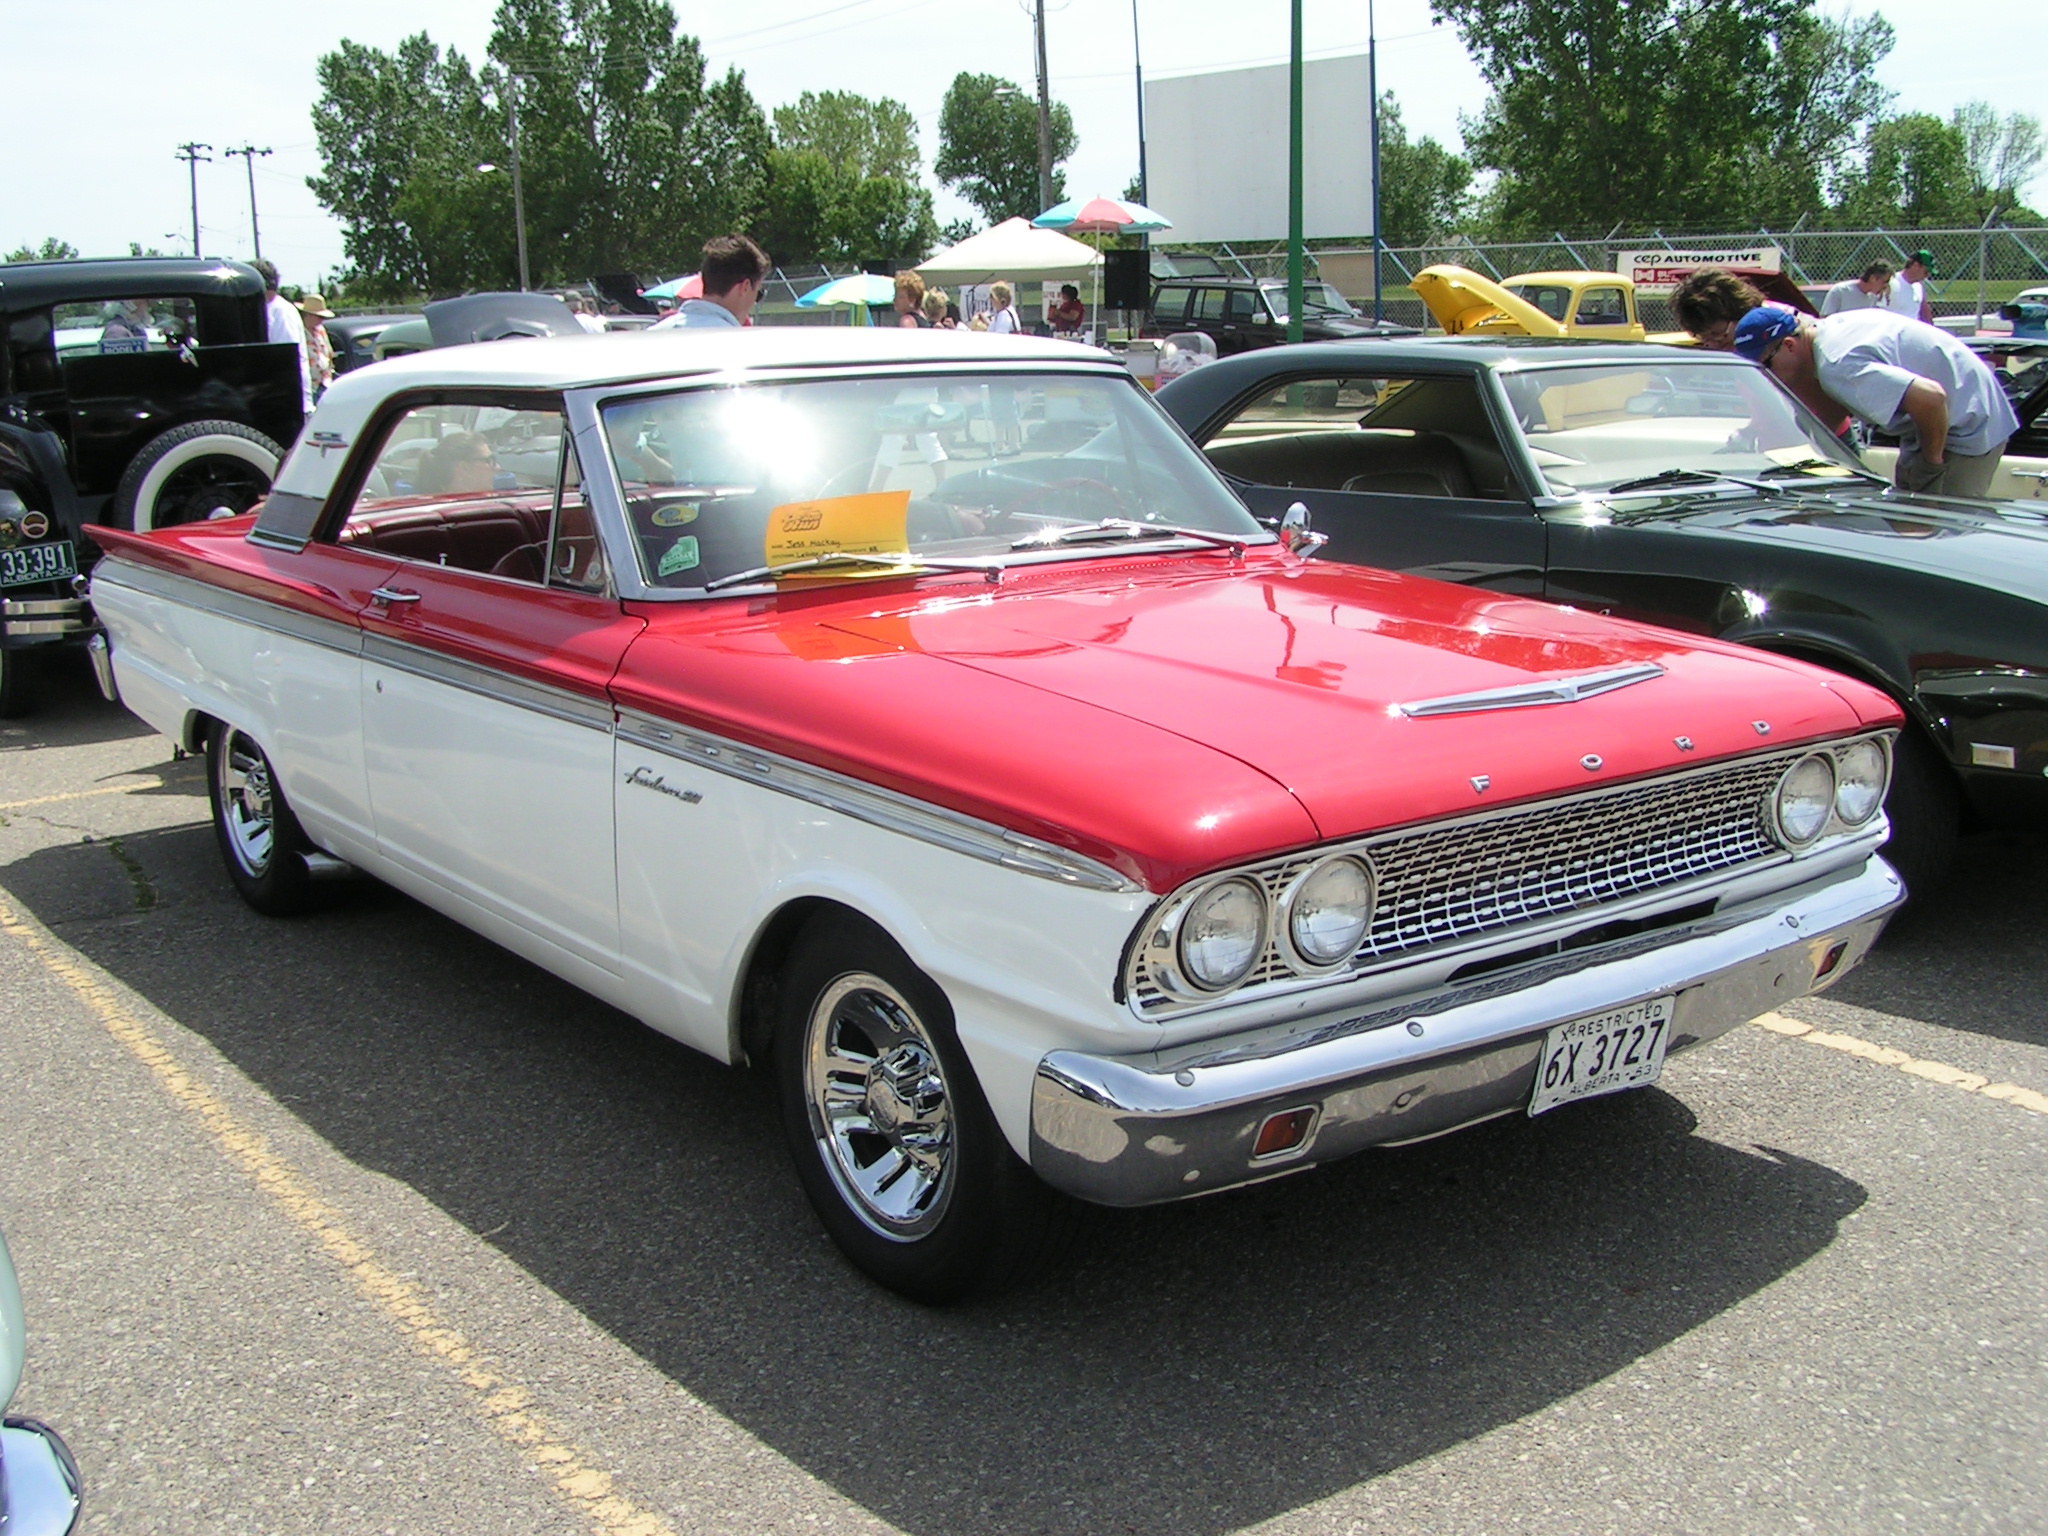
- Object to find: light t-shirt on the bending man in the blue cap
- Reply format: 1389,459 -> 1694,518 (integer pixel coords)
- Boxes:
1812,309 -> 2019,455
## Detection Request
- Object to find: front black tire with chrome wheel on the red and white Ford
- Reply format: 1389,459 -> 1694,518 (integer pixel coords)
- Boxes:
774,911 -> 1079,1305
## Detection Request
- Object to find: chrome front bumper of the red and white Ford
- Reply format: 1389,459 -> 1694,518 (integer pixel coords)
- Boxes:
1030,856 -> 1905,1206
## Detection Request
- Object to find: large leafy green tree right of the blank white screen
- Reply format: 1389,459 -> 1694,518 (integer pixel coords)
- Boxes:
1434,0 -> 1890,236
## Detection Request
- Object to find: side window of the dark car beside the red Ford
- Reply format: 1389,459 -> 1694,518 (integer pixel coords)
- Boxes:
1204,375 -> 1516,500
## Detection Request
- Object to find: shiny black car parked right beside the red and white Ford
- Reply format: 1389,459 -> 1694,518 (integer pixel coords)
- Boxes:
1159,338 -> 2048,891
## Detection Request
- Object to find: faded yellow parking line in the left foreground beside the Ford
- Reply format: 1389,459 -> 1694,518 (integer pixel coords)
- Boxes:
0,903 -> 674,1536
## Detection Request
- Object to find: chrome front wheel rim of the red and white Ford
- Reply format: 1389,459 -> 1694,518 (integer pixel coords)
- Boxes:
803,971 -> 954,1243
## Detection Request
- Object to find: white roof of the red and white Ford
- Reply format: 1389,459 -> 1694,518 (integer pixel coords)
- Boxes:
274,326 -> 1120,500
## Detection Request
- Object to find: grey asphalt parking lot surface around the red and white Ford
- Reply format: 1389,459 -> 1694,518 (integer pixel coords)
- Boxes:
0,668 -> 2048,1536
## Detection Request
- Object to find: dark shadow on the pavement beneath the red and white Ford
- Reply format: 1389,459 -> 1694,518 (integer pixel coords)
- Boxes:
0,825 -> 1866,1536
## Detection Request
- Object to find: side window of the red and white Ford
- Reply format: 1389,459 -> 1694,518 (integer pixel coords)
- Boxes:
340,403 -> 569,582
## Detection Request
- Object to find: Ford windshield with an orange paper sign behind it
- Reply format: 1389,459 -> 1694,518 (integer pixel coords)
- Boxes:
602,373 -> 1270,590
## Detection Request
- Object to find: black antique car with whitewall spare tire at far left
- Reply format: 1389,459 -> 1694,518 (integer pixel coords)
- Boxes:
0,256 -> 303,715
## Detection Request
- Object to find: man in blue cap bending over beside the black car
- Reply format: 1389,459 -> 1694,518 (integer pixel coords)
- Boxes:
1735,309 -> 2019,496
